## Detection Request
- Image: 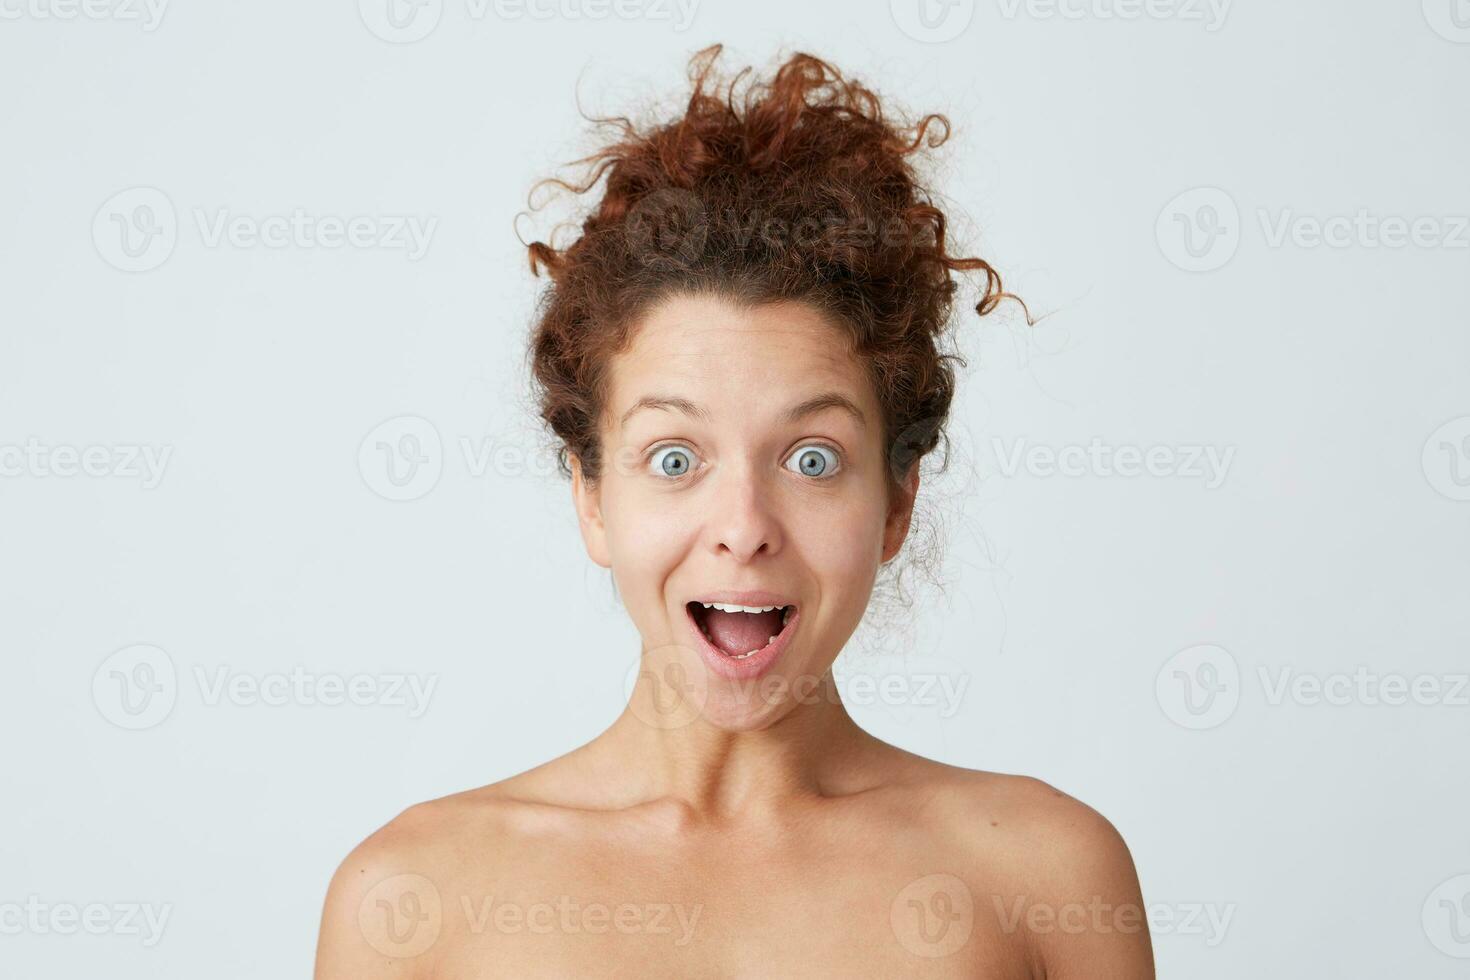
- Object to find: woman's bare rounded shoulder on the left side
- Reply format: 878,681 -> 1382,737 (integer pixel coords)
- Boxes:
315,783 -> 543,980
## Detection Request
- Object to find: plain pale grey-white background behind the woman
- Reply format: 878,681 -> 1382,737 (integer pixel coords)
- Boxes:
0,0 -> 1470,979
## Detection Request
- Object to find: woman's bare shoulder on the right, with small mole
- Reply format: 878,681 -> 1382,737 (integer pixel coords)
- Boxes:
876,763 -> 1154,980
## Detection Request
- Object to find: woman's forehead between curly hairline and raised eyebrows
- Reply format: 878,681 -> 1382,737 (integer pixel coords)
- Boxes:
609,295 -> 878,419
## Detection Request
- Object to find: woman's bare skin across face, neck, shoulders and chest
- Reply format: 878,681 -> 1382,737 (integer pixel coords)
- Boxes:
316,295 -> 1154,980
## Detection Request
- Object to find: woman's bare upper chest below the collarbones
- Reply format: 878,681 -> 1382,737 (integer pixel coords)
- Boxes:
404,845 -> 1029,980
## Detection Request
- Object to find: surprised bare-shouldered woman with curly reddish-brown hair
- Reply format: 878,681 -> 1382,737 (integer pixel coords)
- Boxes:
316,46 -> 1152,980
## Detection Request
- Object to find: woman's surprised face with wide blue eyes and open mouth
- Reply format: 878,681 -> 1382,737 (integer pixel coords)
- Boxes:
573,295 -> 917,730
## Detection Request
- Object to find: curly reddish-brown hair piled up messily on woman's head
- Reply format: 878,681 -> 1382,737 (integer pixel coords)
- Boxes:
528,44 -> 1025,505
